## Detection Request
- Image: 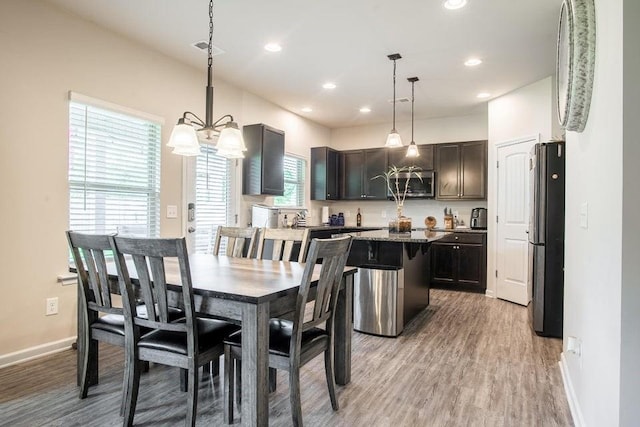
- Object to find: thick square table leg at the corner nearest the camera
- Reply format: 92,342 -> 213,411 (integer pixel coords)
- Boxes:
242,303 -> 269,426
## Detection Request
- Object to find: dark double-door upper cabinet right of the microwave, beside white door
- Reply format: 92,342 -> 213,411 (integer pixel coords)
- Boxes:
435,141 -> 487,200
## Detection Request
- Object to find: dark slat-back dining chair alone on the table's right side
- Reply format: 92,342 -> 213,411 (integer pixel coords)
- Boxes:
224,236 -> 351,426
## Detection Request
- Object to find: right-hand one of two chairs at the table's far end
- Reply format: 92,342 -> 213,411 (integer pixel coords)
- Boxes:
256,228 -> 309,262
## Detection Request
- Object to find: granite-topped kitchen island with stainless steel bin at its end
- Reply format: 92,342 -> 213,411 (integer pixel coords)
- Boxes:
346,230 -> 450,336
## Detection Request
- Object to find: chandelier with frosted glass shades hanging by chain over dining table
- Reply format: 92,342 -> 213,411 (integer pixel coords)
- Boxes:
167,0 -> 247,158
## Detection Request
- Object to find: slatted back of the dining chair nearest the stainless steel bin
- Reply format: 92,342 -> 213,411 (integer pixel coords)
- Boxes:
291,236 -> 351,344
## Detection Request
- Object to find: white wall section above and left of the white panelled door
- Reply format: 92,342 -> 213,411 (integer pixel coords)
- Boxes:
487,77 -> 559,295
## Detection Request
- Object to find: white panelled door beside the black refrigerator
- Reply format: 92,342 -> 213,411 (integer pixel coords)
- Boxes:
496,137 -> 539,306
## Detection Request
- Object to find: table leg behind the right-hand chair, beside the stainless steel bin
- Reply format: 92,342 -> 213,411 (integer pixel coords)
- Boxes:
333,274 -> 353,385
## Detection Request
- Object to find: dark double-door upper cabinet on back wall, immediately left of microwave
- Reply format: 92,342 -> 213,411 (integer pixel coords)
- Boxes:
340,148 -> 387,200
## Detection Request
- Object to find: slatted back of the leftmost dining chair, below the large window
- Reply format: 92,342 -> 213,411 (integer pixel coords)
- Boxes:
66,231 -> 122,314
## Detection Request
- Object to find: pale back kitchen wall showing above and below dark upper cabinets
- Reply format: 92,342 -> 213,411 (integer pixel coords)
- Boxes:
322,114 -> 487,227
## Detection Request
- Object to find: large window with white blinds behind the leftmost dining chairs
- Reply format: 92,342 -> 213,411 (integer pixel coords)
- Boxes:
69,94 -> 161,237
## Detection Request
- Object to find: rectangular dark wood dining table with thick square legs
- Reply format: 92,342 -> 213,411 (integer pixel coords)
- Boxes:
77,254 -> 357,426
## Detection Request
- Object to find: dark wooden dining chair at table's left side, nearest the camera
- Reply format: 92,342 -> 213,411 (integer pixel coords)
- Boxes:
110,236 -> 239,426
